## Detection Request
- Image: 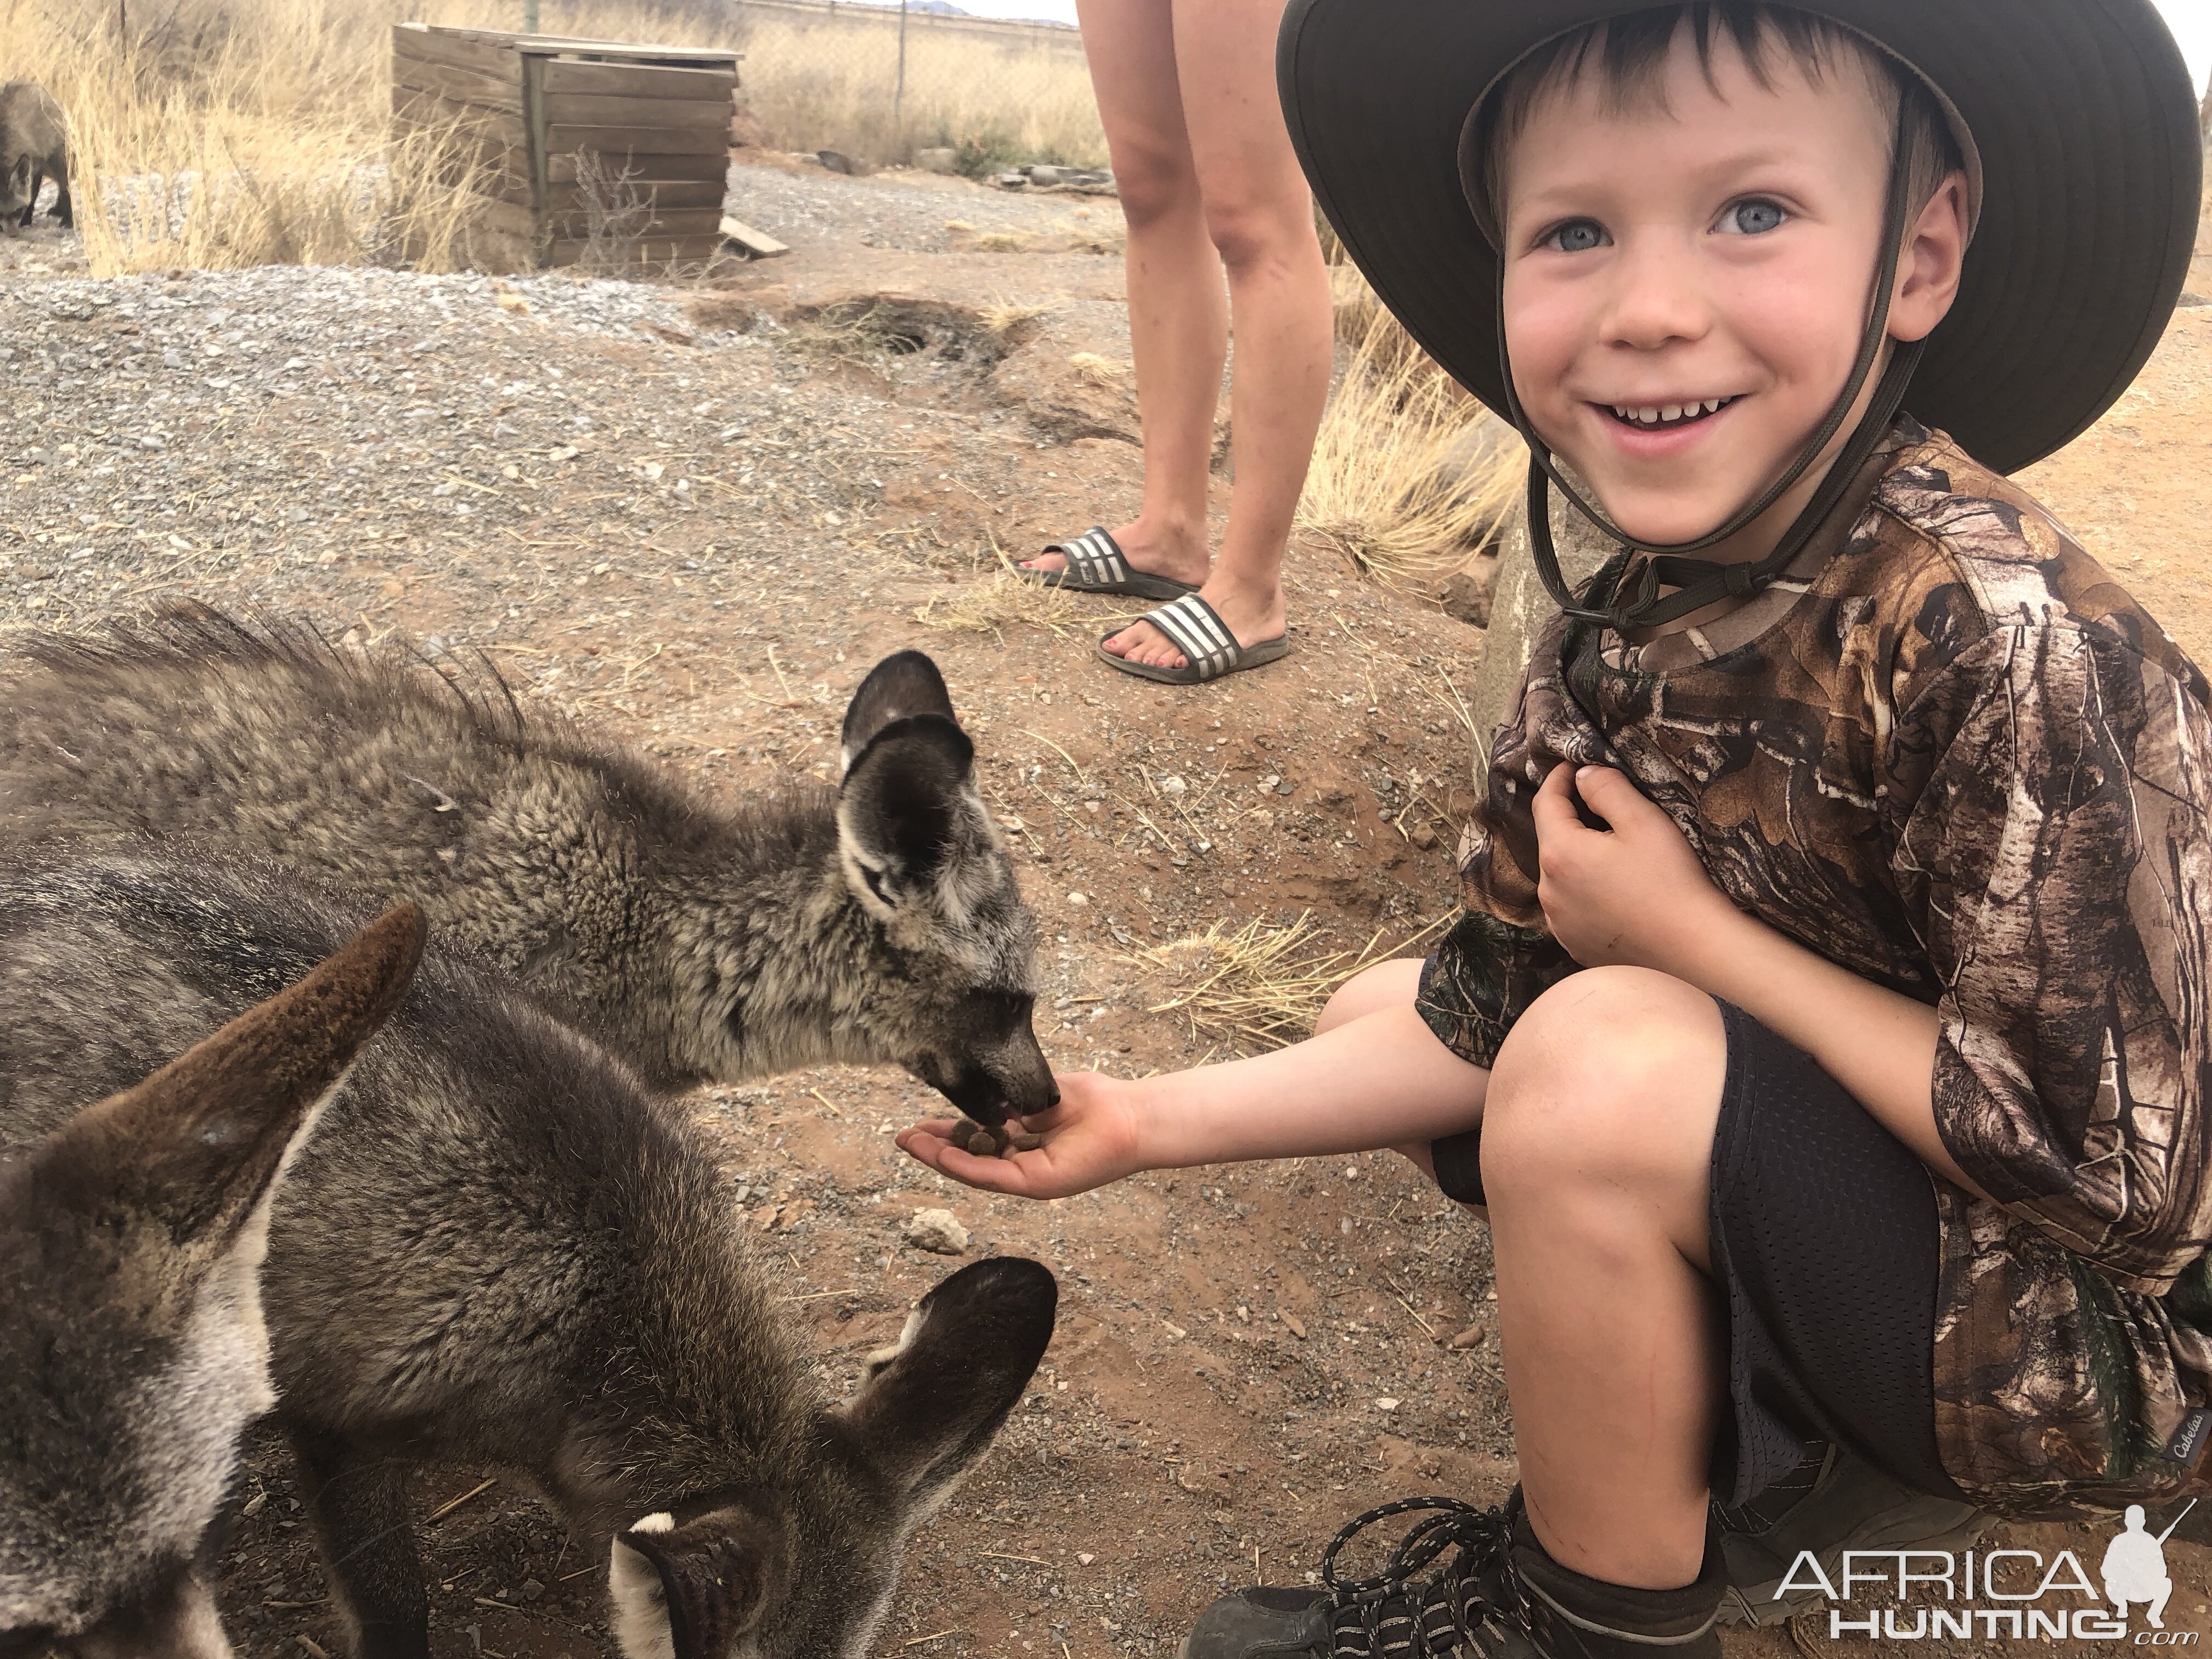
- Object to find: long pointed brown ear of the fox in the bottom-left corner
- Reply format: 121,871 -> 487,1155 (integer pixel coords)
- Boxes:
26,905 -> 422,1256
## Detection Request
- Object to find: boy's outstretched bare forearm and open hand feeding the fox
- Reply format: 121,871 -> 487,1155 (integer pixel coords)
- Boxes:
898,1007 -> 1489,1199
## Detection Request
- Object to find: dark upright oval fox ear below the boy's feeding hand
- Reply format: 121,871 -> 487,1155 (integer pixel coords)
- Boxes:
845,1256 -> 1059,1513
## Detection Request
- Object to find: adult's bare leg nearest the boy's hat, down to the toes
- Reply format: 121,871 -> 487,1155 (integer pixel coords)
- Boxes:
1106,0 -> 1334,668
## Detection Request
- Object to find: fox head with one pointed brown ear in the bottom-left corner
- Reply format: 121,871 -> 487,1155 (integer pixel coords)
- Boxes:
0,907 -> 422,1659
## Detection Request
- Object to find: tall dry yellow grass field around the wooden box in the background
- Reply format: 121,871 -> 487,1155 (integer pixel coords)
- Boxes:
0,0 -> 1104,276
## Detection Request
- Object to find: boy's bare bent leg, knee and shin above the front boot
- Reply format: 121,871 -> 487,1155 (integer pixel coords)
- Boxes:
1482,967 -> 1728,1590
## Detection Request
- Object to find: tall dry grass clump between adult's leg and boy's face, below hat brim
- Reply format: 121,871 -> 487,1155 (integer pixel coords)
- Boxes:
1299,266 -> 1526,584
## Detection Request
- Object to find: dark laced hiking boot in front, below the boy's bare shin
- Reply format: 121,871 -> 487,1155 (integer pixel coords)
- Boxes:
1181,1487 -> 1723,1659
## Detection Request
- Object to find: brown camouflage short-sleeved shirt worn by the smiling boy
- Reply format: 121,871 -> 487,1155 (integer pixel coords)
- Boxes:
1423,420 -> 2212,1511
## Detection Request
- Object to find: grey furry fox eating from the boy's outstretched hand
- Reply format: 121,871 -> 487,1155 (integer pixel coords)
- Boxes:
0,608 -> 1057,1124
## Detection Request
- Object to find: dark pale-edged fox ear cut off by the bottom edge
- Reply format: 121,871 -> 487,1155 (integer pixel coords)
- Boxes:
606,1504 -> 787,1659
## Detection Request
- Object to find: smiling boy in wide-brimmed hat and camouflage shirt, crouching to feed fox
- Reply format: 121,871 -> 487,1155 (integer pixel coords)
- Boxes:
902,0 -> 2212,1659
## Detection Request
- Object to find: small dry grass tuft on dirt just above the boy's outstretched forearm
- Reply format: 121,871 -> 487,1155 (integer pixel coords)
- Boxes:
1121,911 -> 1451,1053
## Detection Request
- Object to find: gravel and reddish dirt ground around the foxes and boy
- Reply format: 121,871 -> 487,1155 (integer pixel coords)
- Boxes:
13,153 -> 2212,1659
